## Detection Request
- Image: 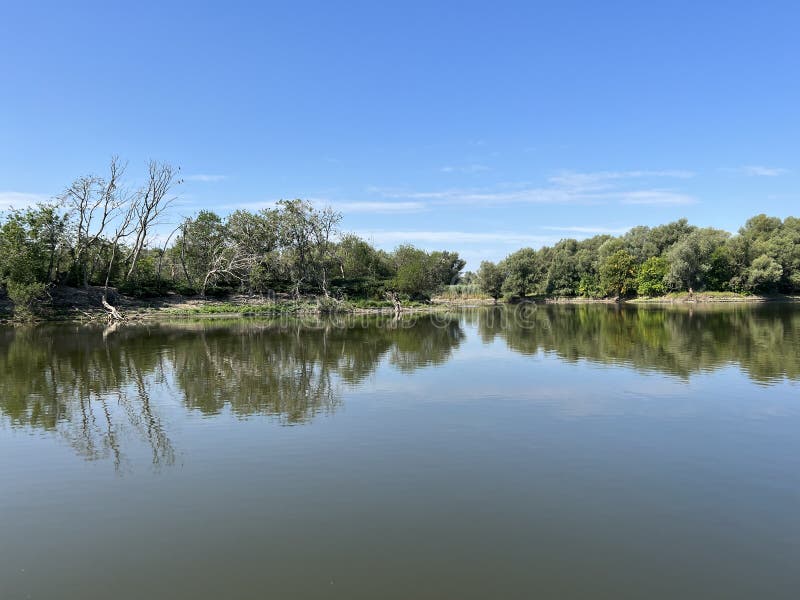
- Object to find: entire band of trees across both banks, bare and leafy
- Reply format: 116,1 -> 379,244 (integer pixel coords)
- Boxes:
0,158 -> 800,309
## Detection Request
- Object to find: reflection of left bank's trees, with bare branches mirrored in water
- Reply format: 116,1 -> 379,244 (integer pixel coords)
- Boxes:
0,315 -> 464,469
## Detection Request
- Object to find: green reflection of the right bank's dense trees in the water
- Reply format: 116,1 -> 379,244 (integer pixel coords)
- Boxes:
466,304 -> 800,384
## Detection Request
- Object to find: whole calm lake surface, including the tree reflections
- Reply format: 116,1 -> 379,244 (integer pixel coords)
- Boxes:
0,305 -> 800,600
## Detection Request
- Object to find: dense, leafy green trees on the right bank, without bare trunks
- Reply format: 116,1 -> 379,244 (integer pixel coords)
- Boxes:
476,214 -> 800,299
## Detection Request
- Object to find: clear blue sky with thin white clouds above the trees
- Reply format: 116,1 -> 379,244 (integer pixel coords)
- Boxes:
0,1 -> 800,268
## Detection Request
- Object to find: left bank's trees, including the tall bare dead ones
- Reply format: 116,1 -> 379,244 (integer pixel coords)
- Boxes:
0,158 -> 465,318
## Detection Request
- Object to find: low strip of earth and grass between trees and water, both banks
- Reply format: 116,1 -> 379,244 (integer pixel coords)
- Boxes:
0,288 -> 800,323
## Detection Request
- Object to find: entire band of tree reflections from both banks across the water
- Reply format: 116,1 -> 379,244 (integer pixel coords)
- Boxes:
0,305 -> 800,469
